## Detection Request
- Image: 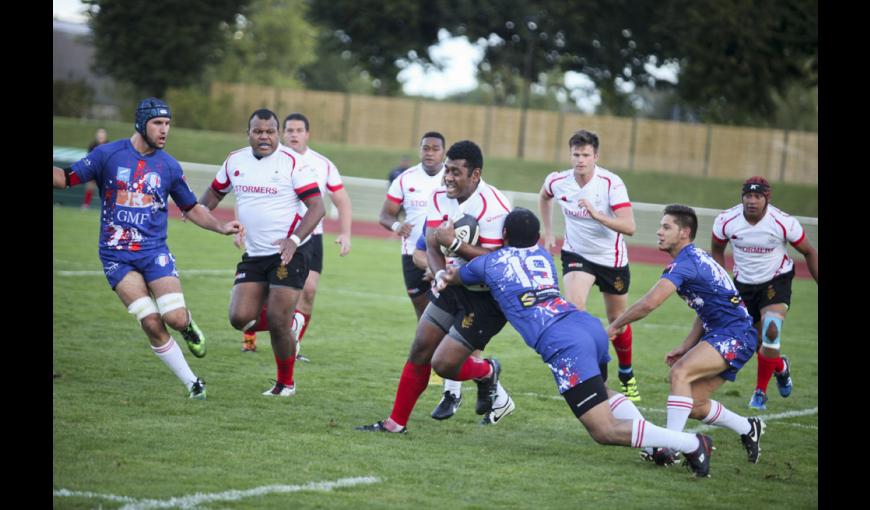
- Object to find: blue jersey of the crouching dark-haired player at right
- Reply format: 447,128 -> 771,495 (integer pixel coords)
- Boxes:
662,244 -> 752,333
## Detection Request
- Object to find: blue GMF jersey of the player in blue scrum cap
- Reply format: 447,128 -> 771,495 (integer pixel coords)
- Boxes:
72,139 -> 196,251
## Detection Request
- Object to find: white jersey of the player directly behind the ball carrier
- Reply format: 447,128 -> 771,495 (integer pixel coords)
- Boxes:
387,163 -> 444,255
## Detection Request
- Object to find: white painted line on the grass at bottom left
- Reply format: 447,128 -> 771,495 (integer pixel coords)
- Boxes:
54,476 -> 381,510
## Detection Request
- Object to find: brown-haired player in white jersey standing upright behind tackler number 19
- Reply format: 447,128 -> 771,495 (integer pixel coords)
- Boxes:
538,130 -> 640,402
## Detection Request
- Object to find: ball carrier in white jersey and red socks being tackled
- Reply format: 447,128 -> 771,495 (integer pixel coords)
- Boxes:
356,138 -> 514,433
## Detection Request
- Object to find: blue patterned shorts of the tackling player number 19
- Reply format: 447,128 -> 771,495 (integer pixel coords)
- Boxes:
535,311 -> 610,393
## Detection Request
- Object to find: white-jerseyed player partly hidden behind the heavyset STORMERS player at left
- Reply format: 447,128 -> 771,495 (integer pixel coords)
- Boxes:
242,113 -> 353,361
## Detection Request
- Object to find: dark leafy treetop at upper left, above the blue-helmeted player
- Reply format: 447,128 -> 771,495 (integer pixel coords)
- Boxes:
82,0 -> 249,97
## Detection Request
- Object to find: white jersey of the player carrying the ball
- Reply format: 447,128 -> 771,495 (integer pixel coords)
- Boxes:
426,179 -> 511,278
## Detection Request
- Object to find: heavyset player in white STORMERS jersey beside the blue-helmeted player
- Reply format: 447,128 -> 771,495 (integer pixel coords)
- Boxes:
201,109 -> 325,397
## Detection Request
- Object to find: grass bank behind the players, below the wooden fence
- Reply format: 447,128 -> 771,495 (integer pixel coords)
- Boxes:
53,117 -> 819,217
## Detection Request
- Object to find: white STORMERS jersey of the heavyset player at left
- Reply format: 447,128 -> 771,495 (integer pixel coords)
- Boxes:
211,146 -> 319,257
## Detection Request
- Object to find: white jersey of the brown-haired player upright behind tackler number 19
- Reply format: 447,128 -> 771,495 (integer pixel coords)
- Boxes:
544,165 -> 631,267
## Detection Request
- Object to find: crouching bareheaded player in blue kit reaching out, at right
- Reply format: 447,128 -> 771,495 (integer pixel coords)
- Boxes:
607,204 -> 764,464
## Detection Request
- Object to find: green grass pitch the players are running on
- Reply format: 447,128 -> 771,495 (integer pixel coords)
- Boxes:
52,208 -> 819,510
